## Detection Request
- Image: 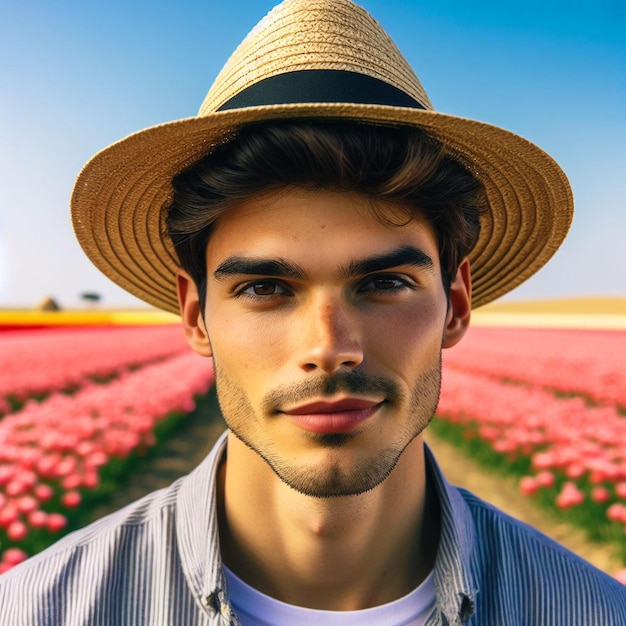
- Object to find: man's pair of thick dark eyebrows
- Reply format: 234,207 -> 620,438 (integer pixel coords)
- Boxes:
213,246 -> 435,281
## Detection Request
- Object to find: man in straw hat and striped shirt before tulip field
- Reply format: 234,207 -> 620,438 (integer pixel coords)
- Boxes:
0,0 -> 626,626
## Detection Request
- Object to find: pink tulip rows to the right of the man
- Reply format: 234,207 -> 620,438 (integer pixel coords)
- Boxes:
433,327 -> 626,579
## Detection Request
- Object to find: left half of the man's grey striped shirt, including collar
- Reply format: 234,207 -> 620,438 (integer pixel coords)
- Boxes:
0,434 -> 226,626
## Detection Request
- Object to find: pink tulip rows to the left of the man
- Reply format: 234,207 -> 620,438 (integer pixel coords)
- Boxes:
0,327 -> 213,573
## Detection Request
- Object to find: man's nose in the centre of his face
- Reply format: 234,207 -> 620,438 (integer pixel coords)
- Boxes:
297,296 -> 364,374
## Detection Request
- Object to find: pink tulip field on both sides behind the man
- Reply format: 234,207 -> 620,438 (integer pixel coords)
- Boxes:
0,326 -> 626,582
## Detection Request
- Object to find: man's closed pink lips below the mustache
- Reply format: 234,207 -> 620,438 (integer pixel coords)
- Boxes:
282,398 -> 383,434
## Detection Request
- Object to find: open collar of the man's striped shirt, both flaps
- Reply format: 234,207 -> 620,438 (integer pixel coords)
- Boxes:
176,431 -> 478,624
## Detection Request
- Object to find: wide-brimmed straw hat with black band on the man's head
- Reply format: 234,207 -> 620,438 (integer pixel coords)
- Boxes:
71,0 -> 573,313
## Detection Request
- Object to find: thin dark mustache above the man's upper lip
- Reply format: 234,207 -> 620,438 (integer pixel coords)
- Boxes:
262,370 -> 401,415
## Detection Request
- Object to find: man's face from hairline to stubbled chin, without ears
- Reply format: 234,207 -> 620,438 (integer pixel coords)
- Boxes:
196,189 -> 468,497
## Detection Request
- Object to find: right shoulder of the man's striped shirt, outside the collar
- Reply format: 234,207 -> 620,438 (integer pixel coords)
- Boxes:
459,489 -> 626,626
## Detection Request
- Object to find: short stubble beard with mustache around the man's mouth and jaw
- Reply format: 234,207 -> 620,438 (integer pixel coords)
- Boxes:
215,353 -> 441,498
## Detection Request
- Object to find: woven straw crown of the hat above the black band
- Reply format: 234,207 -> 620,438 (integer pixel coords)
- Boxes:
198,0 -> 433,115
